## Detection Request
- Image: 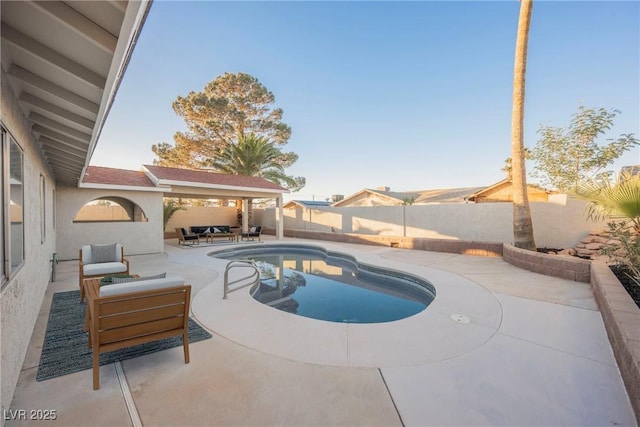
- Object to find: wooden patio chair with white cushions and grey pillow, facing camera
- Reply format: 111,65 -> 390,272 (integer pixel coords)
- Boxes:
78,243 -> 129,302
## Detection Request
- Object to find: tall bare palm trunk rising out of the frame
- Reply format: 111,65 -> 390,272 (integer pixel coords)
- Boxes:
511,0 -> 536,251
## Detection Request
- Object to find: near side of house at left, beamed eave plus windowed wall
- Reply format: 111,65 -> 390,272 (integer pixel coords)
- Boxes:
0,0 -> 154,413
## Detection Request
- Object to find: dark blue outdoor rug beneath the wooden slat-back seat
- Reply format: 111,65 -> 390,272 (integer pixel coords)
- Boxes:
36,291 -> 211,381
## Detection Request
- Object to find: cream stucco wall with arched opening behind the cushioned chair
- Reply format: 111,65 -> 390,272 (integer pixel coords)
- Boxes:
56,186 -> 164,260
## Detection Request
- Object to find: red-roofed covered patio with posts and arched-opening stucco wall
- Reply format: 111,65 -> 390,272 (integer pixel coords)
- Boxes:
56,165 -> 289,260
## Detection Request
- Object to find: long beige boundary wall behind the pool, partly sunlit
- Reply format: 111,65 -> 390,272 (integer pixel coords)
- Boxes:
260,196 -> 606,248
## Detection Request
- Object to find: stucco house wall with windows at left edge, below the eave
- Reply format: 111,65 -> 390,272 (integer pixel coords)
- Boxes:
0,72 -> 56,423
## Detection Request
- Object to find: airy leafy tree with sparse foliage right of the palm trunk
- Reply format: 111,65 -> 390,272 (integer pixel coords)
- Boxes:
532,106 -> 638,192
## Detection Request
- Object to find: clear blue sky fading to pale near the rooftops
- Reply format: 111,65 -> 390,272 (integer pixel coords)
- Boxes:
91,0 -> 640,200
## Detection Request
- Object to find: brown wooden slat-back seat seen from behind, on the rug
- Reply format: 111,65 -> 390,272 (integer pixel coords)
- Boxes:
85,277 -> 191,390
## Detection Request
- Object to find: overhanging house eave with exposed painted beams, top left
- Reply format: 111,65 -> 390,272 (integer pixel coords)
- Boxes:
0,0 -> 152,186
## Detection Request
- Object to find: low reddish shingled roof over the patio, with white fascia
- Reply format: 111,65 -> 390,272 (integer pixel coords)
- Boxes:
80,165 -> 289,199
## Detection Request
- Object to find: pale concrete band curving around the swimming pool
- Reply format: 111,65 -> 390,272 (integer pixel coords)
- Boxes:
191,242 -> 502,368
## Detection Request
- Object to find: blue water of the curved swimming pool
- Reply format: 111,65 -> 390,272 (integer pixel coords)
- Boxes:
212,245 -> 435,323
